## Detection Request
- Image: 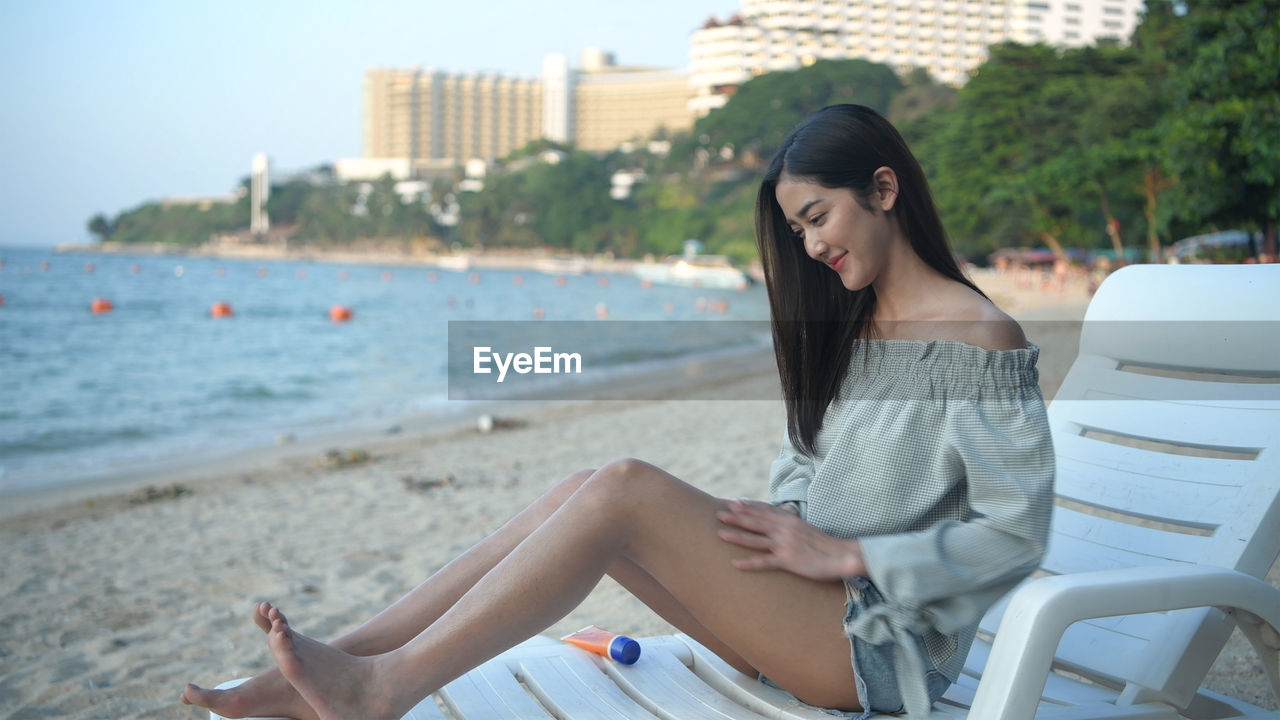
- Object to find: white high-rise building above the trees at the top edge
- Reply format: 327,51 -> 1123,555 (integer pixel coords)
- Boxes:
689,0 -> 1143,115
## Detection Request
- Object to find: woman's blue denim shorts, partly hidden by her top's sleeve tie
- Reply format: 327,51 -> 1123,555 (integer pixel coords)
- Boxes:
760,578 -> 951,720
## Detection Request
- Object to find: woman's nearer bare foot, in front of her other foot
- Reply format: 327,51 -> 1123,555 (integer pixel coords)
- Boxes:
266,607 -> 396,720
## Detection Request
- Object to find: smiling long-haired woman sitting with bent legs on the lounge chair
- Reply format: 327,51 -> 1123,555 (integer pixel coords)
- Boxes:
182,105 -> 1053,720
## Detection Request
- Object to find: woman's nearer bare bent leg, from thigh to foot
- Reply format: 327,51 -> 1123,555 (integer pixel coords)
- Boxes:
268,461 -> 858,719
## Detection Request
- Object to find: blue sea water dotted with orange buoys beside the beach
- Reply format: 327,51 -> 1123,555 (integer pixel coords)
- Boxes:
0,249 -> 768,493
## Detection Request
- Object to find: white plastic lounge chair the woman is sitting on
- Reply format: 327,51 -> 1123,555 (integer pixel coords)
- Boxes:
204,265 -> 1280,720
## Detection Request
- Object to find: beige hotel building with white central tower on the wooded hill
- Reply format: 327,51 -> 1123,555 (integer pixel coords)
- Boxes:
355,49 -> 694,179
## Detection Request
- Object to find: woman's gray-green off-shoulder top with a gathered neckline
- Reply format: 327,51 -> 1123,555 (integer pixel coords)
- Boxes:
769,340 -> 1053,716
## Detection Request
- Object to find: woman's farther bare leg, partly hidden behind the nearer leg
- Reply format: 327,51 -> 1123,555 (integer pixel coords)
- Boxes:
182,470 -> 745,720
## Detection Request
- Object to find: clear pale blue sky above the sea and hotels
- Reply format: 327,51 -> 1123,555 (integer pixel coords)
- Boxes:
0,0 -> 739,247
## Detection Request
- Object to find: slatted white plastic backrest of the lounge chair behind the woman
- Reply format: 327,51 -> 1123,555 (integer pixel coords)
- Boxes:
983,260 -> 1280,707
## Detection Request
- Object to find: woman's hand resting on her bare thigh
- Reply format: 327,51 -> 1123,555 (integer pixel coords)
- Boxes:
716,500 -> 867,580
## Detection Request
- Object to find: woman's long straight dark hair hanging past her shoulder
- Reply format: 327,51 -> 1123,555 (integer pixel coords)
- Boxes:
755,105 -> 982,455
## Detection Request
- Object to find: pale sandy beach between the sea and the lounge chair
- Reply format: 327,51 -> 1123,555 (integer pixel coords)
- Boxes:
0,274 -> 1280,720
